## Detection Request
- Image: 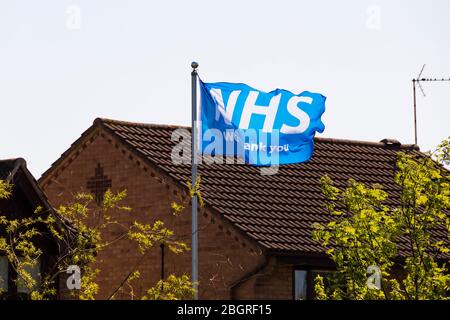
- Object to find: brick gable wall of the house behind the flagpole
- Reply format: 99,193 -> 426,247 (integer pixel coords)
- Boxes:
41,129 -> 268,299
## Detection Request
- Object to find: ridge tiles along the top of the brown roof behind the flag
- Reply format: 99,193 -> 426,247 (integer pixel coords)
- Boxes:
94,118 -> 420,150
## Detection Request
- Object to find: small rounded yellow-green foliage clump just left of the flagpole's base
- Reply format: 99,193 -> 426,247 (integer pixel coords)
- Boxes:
142,274 -> 195,300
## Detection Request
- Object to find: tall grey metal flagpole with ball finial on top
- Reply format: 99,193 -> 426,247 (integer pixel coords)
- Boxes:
191,61 -> 198,300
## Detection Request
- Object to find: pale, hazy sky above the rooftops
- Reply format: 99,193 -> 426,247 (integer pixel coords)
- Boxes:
0,0 -> 450,178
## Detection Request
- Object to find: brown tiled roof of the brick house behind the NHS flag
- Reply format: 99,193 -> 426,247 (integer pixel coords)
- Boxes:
39,118 -> 446,254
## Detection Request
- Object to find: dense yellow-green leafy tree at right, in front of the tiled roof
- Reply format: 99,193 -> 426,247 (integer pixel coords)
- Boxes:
313,139 -> 450,300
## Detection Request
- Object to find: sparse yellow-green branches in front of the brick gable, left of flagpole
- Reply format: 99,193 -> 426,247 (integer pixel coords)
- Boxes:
0,180 -> 199,299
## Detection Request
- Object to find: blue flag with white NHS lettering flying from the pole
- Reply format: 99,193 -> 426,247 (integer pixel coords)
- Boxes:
199,81 -> 326,166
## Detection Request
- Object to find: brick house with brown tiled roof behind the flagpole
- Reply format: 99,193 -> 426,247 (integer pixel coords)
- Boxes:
39,119 -> 419,299
